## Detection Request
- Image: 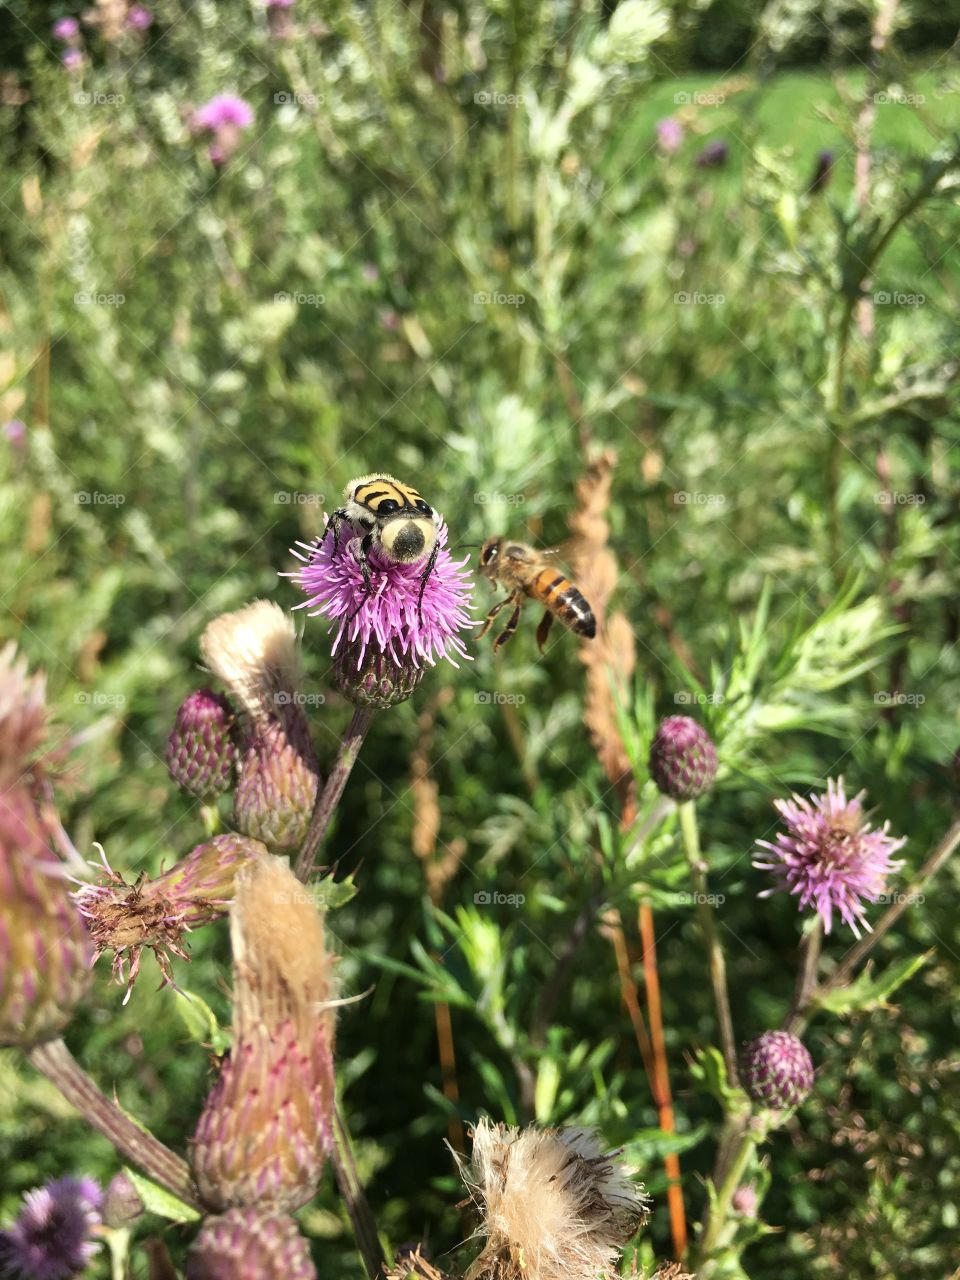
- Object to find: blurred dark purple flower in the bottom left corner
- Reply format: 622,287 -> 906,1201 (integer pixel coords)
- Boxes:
0,1178 -> 104,1280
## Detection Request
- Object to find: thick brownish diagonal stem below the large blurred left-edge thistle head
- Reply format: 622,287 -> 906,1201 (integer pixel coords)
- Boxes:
28,1039 -> 204,1212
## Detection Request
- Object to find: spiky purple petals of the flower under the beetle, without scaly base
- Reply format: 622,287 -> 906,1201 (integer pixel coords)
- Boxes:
285,525 -> 472,668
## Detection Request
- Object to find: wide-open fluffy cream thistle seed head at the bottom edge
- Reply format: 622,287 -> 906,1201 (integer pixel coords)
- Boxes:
461,1120 -> 648,1280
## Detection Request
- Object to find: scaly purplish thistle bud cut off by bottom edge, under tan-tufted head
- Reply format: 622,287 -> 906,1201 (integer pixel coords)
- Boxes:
187,1208 -> 316,1280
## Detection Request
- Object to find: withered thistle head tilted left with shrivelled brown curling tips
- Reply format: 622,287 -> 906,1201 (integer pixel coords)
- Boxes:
73,835 -> 268,1004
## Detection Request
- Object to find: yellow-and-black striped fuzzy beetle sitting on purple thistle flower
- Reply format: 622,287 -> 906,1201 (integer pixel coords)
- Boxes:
321,472 -> 440,622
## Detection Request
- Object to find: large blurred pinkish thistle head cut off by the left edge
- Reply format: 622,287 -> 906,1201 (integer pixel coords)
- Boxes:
0,645 -> 93,1048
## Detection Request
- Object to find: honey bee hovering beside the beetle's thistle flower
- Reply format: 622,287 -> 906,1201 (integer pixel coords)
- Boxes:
477,538 -> 596,653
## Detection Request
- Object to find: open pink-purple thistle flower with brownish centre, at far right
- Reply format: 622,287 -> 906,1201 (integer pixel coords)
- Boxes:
754,778 -> 906,938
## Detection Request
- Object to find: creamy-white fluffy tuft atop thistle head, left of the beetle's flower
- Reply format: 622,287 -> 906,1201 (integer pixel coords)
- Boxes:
200,600 -> 303,728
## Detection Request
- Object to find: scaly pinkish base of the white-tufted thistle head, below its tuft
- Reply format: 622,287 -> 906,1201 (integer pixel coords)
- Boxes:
233,708 -> 320,851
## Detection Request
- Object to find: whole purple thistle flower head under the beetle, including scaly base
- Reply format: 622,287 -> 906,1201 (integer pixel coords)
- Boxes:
284,525 -> 472,705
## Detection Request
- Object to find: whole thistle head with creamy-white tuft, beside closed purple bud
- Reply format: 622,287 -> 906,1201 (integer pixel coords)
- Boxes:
200,600 -> 320,850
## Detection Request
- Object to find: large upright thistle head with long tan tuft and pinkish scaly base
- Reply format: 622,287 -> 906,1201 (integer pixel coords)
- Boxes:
191,858 -> 334,1213
